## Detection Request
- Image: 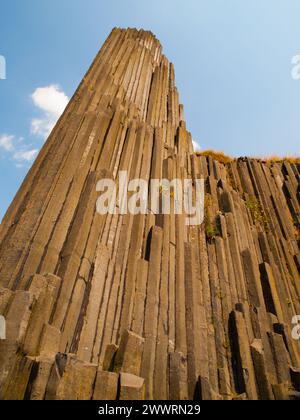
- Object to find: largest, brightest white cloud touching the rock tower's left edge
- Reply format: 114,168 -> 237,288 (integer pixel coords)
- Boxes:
31,85 -> 69,138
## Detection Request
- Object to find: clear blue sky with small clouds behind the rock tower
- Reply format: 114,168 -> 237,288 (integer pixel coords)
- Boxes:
0,0 -> 300,219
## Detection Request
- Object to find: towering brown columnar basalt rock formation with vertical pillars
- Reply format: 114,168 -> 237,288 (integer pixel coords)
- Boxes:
0,29 -> 300,400
